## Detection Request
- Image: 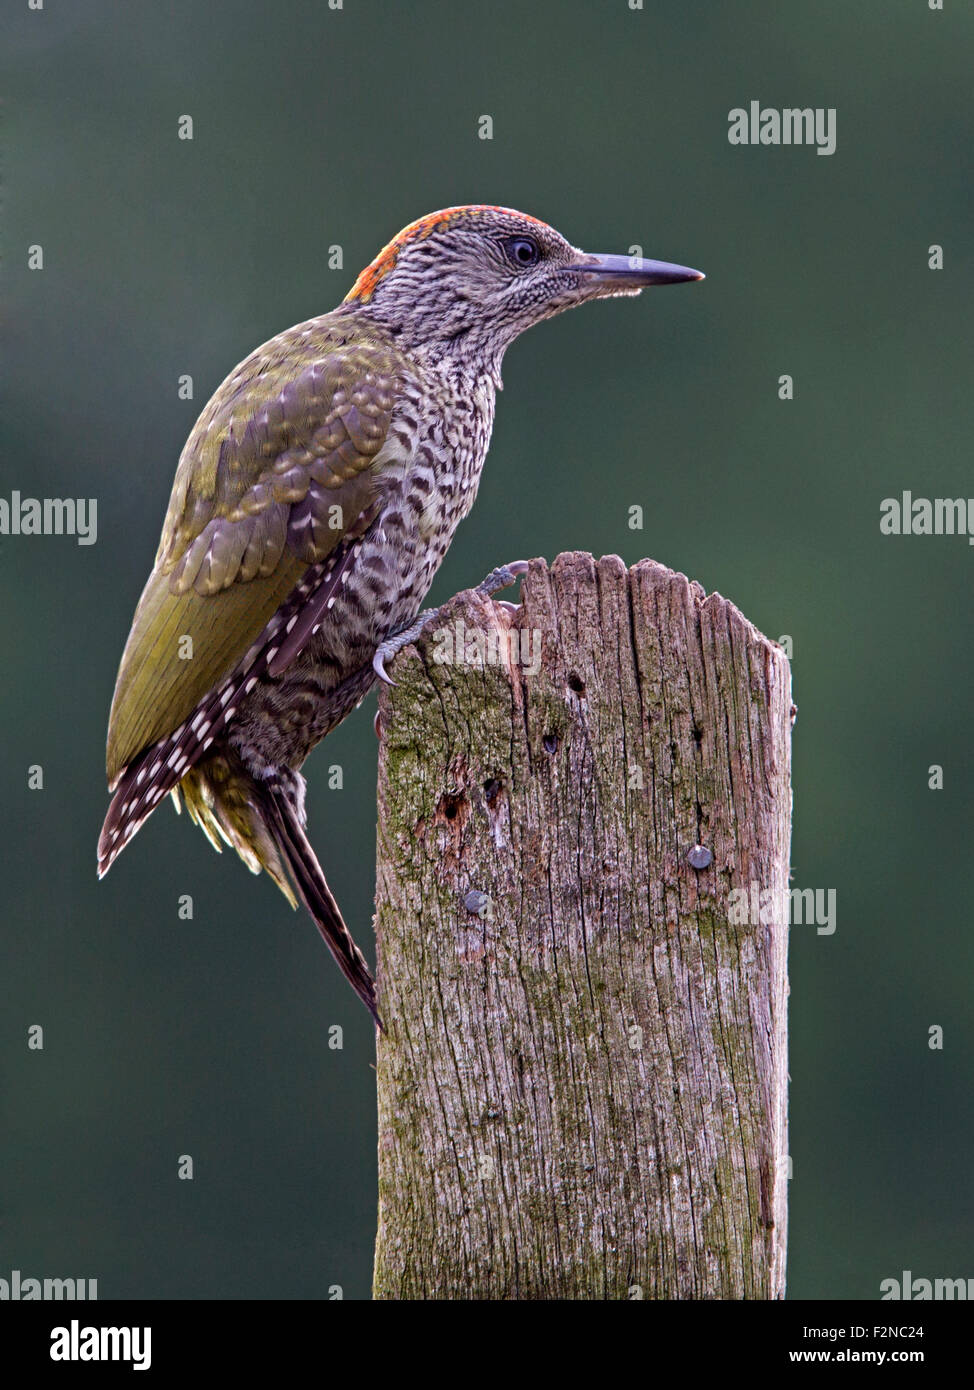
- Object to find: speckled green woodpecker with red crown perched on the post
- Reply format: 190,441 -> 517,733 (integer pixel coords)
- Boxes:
99,204 -> 703,1026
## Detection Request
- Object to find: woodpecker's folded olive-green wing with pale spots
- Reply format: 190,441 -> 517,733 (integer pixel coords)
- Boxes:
107,316 -> 400,785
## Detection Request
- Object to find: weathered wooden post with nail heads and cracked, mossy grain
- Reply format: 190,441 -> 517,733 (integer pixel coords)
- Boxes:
374,553 -> 793,1298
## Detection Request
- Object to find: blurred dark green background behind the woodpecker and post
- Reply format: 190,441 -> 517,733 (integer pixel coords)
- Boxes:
0,0 -> 974,1298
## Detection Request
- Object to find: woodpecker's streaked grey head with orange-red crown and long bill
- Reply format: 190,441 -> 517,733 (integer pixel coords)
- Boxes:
345,204 -> 703,375
